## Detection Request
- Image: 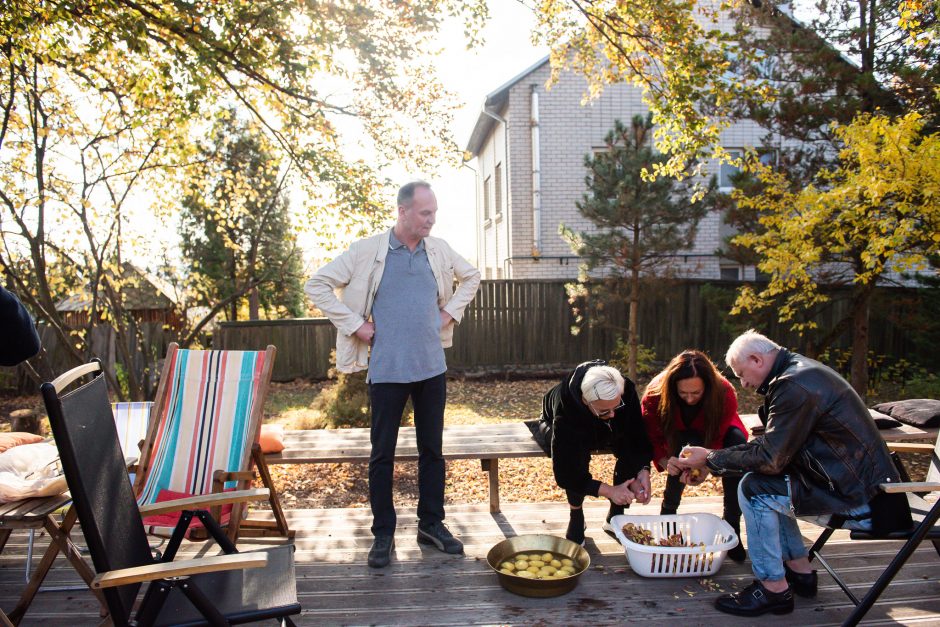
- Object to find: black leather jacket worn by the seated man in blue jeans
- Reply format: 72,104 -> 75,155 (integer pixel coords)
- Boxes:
708,349 -> 900,515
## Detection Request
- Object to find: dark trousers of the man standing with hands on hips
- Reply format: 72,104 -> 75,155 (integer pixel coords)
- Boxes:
369,374 -> 447,536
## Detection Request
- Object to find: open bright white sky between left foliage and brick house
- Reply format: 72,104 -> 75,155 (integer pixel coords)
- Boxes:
400,0 -> 548,263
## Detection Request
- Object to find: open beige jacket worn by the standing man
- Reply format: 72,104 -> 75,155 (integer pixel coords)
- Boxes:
304,231 -> 480,372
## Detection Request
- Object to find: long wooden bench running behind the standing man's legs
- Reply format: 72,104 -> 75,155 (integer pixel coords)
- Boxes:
265,422 -> 545,513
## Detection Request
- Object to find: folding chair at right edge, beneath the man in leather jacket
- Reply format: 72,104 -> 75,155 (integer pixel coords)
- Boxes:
809,437 -> 940,625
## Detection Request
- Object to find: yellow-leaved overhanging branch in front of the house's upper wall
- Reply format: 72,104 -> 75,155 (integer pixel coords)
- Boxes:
535,0 -> 773,186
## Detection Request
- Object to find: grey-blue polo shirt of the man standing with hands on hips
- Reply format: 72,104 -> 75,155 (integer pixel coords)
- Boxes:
369,230 -> 447,383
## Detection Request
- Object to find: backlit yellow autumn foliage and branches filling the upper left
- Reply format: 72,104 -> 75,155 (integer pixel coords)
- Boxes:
0,0 -> 486,397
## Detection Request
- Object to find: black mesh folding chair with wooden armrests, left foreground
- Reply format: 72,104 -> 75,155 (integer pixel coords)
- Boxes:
41,362 -> 301,625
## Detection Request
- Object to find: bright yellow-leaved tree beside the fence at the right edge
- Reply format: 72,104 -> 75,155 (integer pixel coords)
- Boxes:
732,113 -> 940,390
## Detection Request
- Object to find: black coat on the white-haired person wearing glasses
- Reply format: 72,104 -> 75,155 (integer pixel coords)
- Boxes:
535,360 -> 653,496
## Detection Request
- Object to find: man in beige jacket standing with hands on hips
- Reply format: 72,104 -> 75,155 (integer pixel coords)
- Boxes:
304,181 -> 480,568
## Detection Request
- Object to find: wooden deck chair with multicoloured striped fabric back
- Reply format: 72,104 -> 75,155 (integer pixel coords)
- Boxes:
134,343 -> 292,541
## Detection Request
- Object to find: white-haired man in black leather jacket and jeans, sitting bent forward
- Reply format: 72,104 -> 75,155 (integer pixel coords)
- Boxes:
669,331 -> 910,616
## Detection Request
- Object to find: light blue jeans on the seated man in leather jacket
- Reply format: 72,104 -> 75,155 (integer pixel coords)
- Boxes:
738,472 -> 870,581
